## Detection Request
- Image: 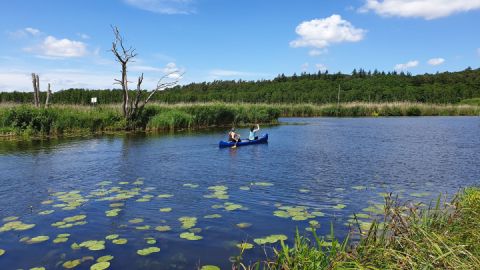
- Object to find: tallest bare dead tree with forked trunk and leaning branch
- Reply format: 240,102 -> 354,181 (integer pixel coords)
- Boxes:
111,26 -> 183,125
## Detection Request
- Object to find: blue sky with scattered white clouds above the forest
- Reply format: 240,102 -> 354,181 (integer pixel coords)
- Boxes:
0,0 -> 480,91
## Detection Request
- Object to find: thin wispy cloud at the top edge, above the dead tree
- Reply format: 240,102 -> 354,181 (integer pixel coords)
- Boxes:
124,0 -> 195,14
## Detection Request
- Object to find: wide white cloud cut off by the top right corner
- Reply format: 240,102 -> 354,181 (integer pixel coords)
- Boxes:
360,0 -> 480,20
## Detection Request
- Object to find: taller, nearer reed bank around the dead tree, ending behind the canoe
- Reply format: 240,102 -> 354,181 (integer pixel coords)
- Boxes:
0,103 -> 280,137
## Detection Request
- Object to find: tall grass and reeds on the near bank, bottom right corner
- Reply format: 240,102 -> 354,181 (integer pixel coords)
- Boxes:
240,188 -> 480,270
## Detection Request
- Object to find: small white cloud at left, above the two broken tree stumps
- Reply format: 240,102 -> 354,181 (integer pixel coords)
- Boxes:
24,36 -> 88,59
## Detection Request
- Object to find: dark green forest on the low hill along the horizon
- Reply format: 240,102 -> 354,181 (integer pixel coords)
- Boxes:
0,68 -> 480,104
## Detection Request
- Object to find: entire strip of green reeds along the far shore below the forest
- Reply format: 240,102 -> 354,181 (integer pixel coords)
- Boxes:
0,102 -> 480,139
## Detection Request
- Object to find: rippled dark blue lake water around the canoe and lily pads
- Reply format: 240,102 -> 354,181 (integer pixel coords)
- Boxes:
0,117 -> 480,269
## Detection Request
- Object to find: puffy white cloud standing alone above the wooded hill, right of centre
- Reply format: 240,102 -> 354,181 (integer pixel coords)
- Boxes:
290,14 -> 366,49
